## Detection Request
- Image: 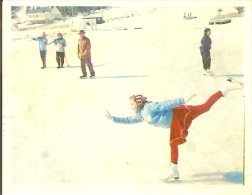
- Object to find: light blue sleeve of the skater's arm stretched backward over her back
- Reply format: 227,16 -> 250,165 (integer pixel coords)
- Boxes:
147,98 -> 185,112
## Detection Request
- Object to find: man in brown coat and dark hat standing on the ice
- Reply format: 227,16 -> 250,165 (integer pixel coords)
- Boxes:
77,30 -> 95,79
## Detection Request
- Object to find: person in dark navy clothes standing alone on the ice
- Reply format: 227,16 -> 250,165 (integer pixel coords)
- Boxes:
200,28 -> 214,75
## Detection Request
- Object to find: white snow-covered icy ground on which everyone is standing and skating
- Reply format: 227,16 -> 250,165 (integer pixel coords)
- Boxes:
3,4 -> 251,194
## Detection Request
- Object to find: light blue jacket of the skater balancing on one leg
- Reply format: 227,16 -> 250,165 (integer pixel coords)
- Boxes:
113,98 -> 185,128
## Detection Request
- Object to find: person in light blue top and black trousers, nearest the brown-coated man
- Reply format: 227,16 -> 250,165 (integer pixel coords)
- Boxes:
54,33 -> 66,68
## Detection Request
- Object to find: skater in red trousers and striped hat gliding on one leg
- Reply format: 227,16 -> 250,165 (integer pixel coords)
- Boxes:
106,82 -> 243,181
